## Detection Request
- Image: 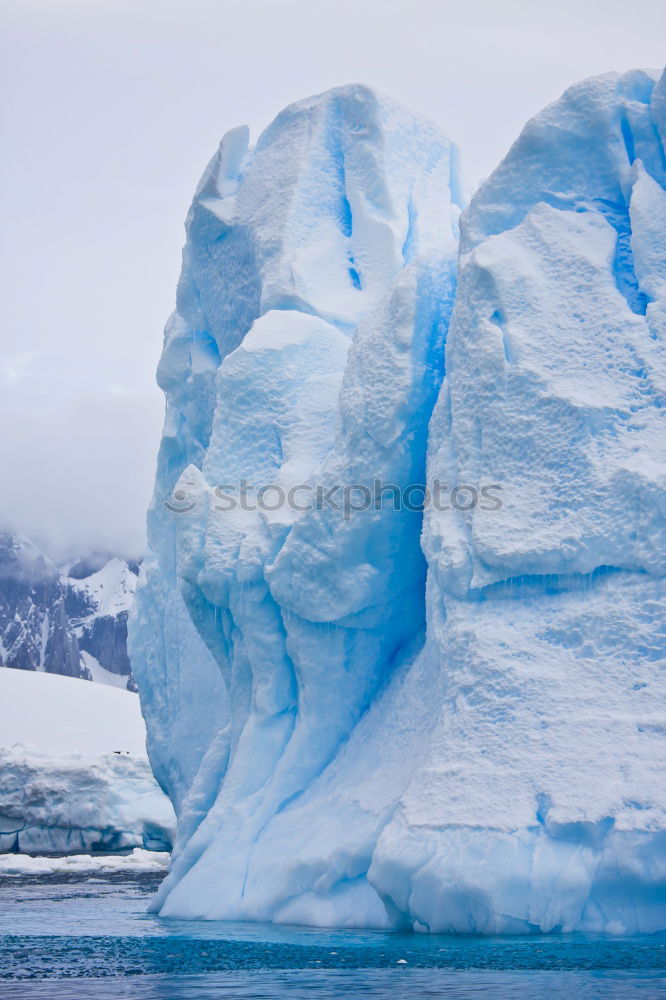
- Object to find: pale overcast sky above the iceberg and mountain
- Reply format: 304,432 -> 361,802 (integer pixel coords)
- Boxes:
0,0 -> 666,557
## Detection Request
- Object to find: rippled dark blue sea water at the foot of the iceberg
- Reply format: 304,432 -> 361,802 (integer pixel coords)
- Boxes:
0,874 -> 666,1000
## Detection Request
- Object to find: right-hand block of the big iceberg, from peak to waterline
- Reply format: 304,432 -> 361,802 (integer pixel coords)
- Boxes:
404,66 -> 666,933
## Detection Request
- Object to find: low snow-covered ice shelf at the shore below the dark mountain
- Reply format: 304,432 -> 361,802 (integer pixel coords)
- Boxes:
0,669 -> 175,853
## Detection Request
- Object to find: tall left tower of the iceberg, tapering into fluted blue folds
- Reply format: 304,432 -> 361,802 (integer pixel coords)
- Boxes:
132,87 -> 461,896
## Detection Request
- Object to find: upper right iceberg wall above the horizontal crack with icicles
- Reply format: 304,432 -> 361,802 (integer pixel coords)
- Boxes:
425,71 -> 666,596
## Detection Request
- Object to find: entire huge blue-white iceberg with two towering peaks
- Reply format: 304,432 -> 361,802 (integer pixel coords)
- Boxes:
130,71 -> 666,934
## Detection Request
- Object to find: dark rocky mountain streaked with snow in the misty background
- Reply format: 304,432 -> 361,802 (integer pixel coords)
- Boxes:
0,532 -> 138,690
